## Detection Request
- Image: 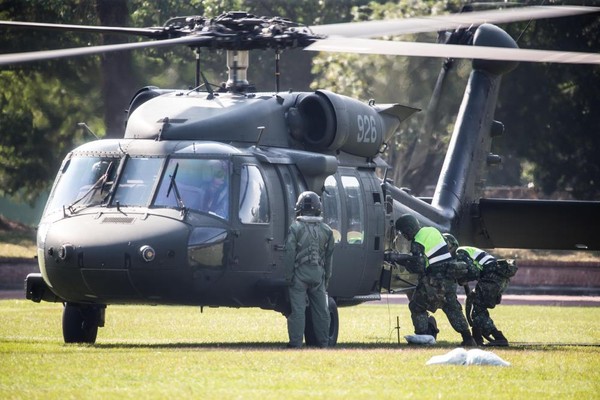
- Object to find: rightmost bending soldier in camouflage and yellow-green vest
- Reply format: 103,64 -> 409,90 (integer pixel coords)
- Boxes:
444,234 -> 517,346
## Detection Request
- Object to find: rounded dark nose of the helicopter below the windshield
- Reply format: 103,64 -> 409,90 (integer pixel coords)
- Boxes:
38,214 -> 191,302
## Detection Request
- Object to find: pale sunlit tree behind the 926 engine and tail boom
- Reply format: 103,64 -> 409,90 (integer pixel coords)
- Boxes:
312,0 -> 469,194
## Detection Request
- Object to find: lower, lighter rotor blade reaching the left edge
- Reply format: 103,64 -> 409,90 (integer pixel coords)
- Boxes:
0,36 -> 212,65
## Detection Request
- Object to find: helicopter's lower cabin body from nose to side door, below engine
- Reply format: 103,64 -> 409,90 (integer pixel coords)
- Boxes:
38,140 -> 396,309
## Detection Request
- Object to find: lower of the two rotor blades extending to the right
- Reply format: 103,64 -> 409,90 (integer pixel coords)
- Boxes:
304,38 -> 600,64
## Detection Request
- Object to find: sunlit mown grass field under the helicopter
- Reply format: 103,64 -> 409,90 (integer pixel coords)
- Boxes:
0,300 -> 600,400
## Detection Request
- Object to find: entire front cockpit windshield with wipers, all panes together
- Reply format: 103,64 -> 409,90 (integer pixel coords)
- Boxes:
45,156 -> 231,219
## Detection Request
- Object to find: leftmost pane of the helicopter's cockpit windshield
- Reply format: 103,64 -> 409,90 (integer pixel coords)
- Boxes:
45,156 -> 120,214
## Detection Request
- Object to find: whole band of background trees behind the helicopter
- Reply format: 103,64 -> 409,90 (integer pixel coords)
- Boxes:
0,0 -> 600,208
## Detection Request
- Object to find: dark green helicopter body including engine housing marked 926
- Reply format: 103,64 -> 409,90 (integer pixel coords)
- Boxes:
30,89 -> 414,310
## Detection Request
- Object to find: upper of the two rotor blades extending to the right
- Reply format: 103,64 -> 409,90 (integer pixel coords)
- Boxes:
310,6 -> 600,38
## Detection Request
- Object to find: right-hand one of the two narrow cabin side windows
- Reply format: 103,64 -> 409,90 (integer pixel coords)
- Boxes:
341,175 -> 365,244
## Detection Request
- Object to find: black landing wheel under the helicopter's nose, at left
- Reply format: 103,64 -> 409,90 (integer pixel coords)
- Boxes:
62,303 -> 103,344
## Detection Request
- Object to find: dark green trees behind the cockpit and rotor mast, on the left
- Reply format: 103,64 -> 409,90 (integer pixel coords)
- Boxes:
0,0 -> 365,202
